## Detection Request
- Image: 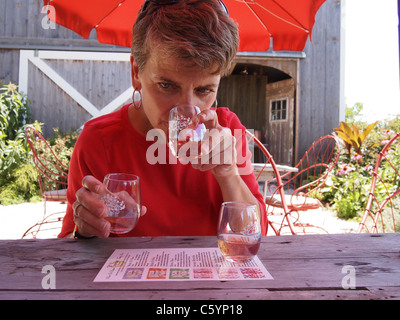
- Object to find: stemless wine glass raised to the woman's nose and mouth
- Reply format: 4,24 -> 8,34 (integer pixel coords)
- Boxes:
168,105 -> 206,160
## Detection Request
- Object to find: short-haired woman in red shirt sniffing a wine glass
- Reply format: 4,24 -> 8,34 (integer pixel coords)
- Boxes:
59,0 -> 266,238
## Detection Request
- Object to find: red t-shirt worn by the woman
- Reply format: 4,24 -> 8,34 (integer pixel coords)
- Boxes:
59,105 -> 267,237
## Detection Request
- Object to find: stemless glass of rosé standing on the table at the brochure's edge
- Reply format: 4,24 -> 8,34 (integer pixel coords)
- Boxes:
218,201 -> 261,263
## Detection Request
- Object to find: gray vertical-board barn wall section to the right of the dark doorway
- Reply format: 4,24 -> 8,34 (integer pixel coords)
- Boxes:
297,0 -> 344,156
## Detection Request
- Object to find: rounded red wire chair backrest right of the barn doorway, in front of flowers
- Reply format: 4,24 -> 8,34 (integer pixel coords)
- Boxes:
282,135 -> 340,201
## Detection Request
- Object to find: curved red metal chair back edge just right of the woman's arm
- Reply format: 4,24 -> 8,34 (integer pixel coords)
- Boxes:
246,130 -> 295,235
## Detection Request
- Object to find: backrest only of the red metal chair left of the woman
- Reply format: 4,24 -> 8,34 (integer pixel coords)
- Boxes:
25,127 -> 68,201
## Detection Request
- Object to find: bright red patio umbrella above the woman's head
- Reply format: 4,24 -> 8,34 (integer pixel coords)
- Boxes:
43,0 -> 325,51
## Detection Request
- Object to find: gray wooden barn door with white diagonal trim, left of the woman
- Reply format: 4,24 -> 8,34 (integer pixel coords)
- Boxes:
19,50 -> 133,136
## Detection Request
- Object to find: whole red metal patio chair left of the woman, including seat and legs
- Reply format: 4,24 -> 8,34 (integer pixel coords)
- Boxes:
22,127 -> 68,238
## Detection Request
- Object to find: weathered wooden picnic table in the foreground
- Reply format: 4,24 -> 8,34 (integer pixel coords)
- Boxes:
0,233 -> 400,303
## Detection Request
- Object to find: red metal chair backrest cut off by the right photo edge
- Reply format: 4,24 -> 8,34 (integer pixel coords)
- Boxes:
357,132 -> 400,233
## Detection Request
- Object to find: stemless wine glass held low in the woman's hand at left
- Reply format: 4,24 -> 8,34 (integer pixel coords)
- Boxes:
101,173 -> 142,234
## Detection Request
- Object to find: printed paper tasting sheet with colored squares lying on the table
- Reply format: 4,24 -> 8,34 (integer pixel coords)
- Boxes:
94,248 -> 273,282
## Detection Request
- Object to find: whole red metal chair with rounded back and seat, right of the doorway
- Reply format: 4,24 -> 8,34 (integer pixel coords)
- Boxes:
265,135 -> 340,234
